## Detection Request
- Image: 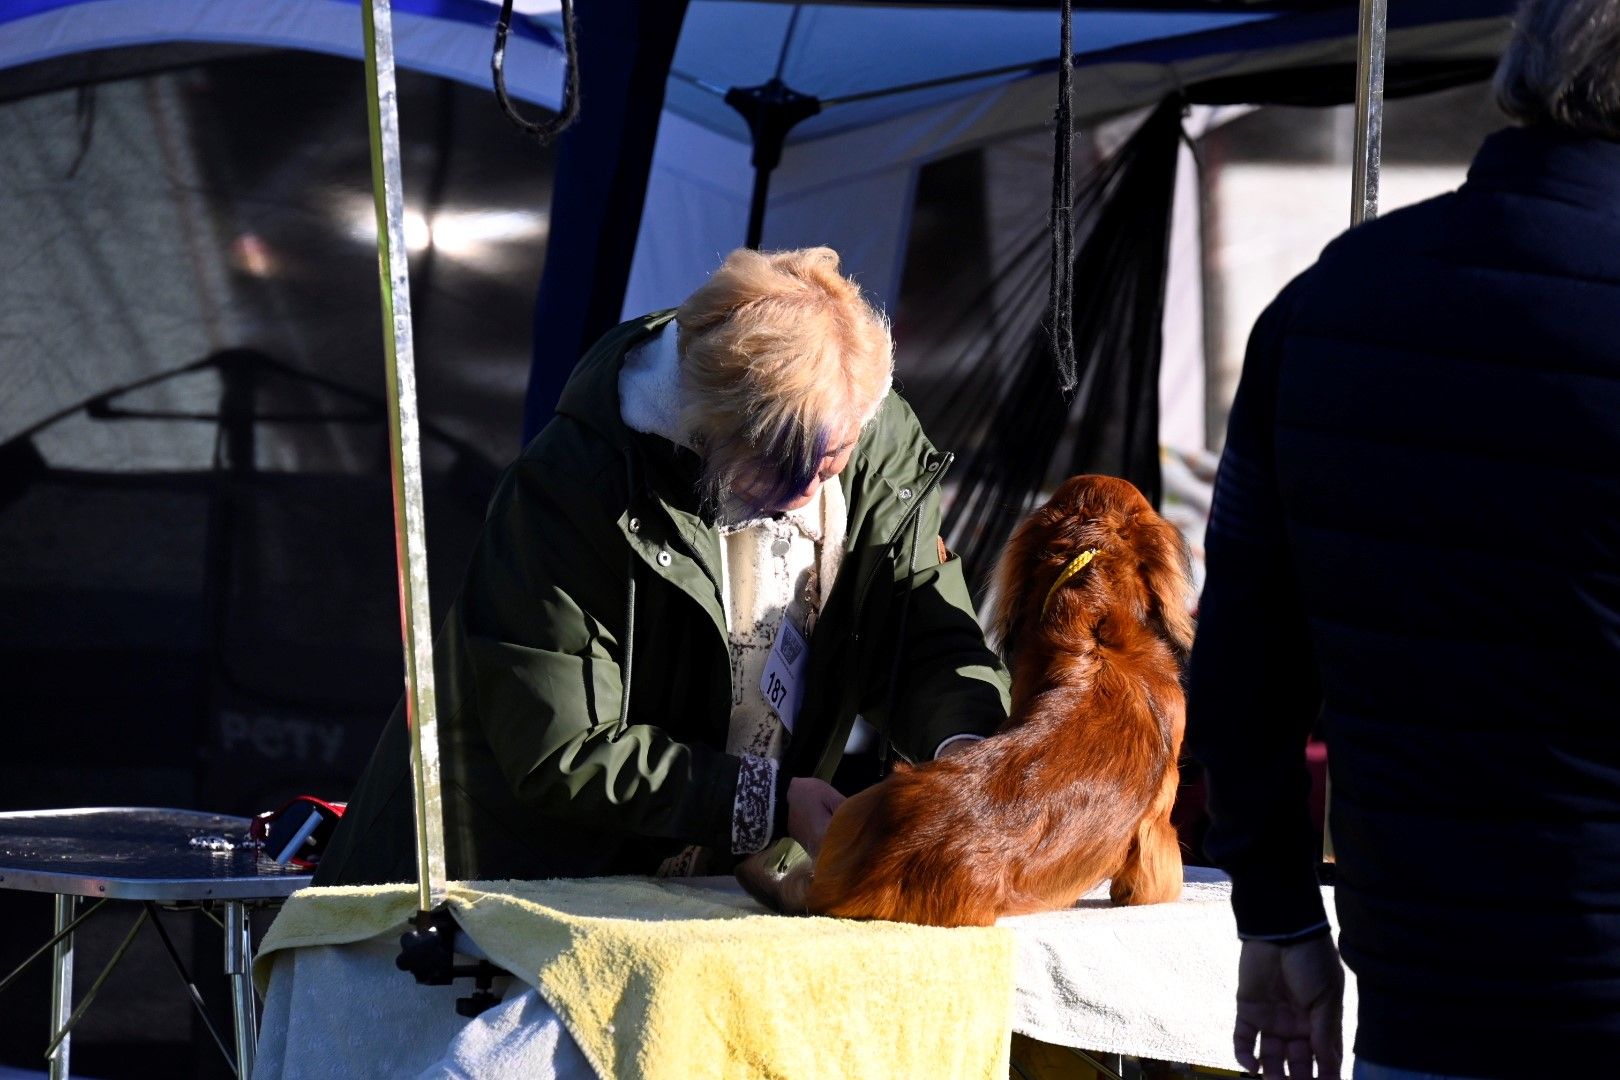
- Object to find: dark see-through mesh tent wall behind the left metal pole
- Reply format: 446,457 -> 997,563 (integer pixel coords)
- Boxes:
0,49 -> 552,1077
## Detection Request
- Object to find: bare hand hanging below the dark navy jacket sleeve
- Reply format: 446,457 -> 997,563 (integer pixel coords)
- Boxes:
1233,934 -> 1345,1080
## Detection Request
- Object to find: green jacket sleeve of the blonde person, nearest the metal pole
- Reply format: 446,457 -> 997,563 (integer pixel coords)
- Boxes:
458,460 -> 740,850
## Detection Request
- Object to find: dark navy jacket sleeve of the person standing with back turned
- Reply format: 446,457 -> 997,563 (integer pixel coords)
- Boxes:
1187,283 -> 1327,939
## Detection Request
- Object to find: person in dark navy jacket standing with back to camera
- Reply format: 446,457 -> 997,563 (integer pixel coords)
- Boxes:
1187,0 -> 1620,1080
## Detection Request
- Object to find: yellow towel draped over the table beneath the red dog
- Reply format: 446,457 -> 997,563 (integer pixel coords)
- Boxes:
254,878 -> 1013,1080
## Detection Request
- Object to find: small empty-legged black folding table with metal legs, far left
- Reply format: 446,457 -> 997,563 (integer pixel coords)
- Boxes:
0,806 -> 309,1080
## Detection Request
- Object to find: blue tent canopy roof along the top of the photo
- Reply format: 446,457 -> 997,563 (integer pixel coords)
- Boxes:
0,0 -> 1513,142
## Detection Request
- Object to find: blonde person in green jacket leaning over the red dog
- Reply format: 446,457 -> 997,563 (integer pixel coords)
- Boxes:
316,248 -> 1006,884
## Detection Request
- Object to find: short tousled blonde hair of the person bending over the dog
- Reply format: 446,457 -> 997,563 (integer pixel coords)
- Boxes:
676,248 -> 894,510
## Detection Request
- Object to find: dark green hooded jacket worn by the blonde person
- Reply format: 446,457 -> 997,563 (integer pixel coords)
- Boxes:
316,311 -> 1008,884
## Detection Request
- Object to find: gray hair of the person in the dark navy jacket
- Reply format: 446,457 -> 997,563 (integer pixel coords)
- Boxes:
1497,0 -> 1620,141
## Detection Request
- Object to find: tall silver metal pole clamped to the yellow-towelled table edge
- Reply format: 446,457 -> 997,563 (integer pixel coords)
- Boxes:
360,0 -> 446,913
